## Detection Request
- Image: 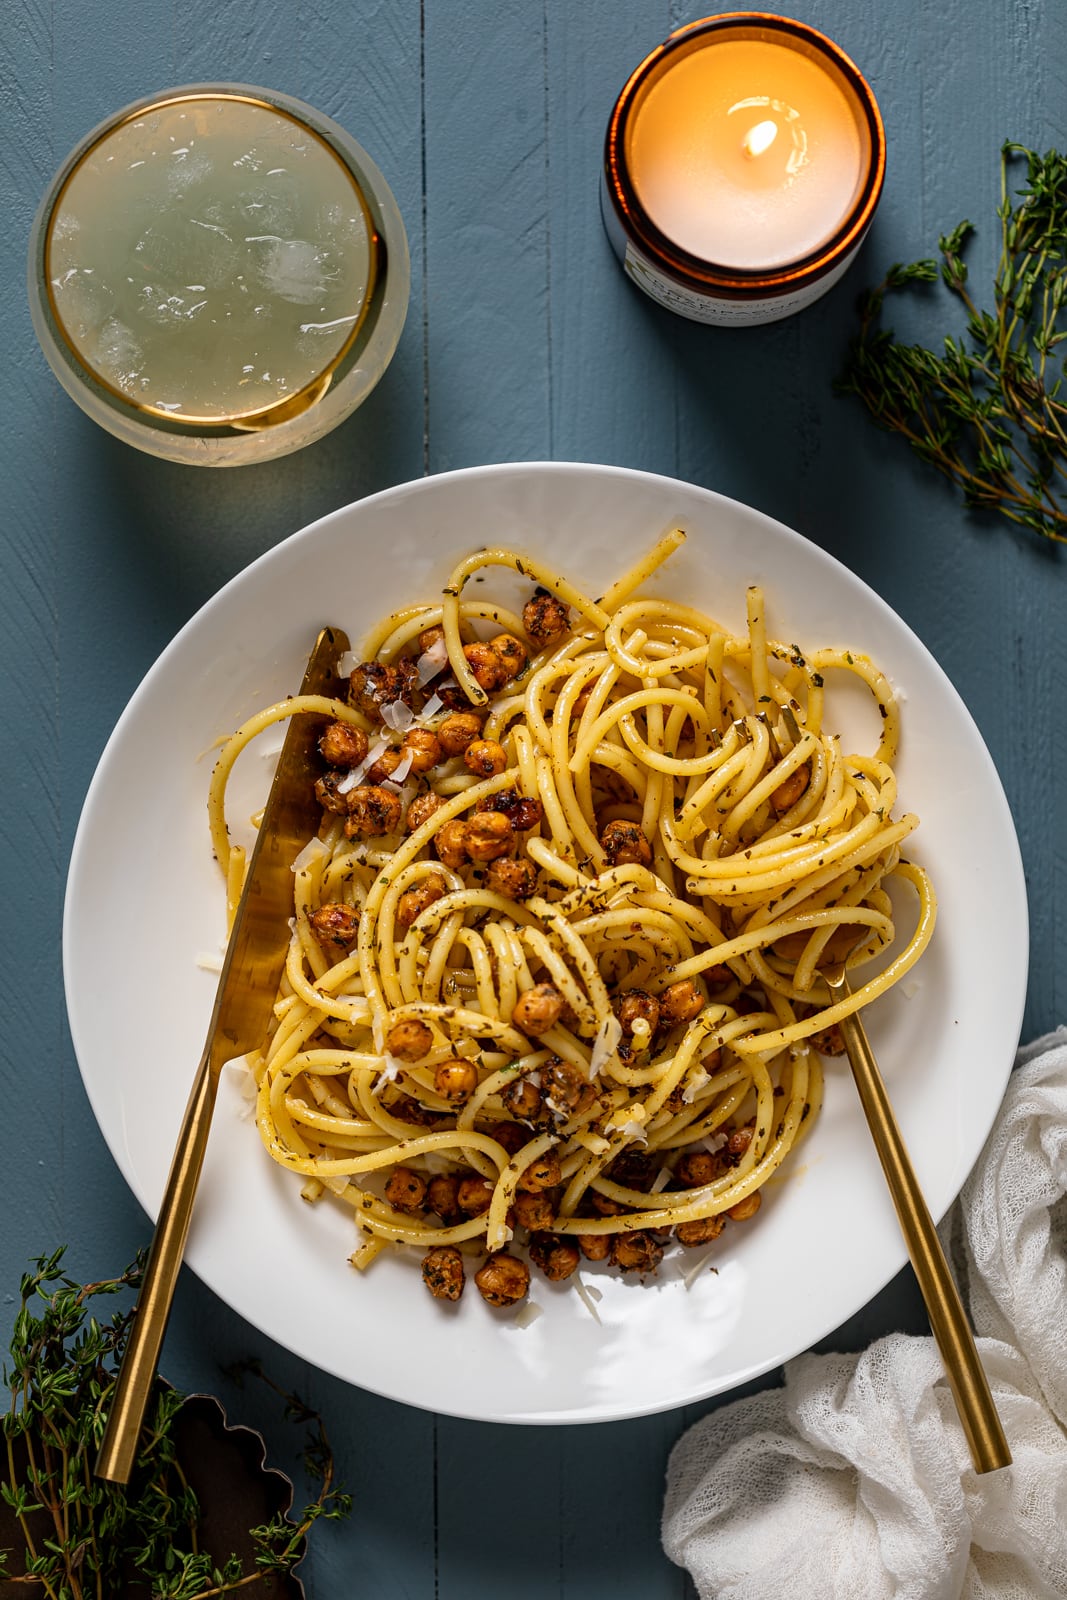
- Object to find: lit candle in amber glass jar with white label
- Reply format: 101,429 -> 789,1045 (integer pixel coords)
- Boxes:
603,13 -> 885,323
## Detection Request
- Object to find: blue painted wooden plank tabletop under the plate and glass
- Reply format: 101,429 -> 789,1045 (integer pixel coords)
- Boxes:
0,0 -> 1067,1600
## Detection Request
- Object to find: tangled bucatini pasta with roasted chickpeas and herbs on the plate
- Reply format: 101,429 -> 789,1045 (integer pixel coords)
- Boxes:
210,531 -> 934,1306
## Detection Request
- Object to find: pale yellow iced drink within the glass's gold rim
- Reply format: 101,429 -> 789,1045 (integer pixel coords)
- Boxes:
46,93 -> 378,427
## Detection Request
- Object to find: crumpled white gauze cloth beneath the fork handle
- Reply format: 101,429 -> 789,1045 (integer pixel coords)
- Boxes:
662,1029 -> 1067,1600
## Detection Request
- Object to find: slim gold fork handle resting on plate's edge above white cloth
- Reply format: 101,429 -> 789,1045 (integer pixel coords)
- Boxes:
838,1014 -> 1011,1472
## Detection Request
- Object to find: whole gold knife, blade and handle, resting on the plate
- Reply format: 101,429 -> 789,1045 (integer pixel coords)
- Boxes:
96,627 -> 349,1483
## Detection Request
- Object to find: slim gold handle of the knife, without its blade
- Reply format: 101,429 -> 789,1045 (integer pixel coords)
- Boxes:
96,1048 -> 218,1483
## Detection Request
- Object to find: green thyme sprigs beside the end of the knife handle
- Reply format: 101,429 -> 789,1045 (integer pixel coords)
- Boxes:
0,1250 -> 350,1600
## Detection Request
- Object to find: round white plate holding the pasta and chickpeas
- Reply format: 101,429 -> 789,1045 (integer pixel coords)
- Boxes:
64,462 -> 1027,1422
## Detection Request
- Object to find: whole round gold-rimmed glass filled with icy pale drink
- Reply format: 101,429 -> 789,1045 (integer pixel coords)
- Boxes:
30,86 -> 408,464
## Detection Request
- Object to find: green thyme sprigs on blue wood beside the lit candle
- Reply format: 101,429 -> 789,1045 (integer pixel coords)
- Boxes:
838,142 -> 1067,542
